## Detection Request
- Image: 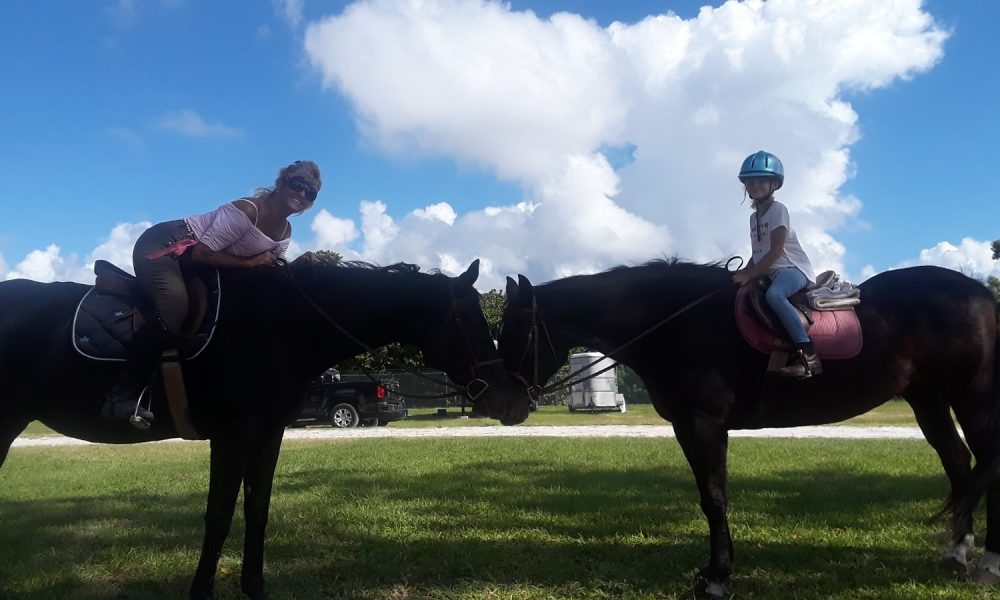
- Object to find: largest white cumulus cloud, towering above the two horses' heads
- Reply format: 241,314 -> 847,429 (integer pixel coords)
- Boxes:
305,0 -> 947,286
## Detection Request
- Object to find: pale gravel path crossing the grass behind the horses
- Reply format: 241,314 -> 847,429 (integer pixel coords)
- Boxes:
12,425 -> 924,448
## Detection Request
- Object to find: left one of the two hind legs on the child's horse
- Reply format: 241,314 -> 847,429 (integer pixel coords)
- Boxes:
906,392 -> 974,573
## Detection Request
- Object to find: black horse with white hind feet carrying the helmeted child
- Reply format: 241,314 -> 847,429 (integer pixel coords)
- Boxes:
499,260 -> 1000,598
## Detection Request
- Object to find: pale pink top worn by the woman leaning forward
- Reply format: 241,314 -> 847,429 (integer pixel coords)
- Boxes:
184,200 -> 290,258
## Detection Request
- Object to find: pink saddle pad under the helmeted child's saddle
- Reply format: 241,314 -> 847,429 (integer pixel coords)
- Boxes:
736,285 -> 862,360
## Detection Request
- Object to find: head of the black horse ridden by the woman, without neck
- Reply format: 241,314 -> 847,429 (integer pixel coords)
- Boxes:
422,259 -> 528,425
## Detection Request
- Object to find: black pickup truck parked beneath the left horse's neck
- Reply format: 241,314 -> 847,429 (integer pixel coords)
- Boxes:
292,377 -> 408,427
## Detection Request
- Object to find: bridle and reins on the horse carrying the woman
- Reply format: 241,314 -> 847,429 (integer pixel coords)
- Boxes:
288,276 -> 503,402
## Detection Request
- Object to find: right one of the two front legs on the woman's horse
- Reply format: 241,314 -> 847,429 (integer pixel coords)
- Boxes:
240,425 -> 285,599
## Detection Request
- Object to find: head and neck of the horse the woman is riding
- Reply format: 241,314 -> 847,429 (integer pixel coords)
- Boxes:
282,260 -> 528,425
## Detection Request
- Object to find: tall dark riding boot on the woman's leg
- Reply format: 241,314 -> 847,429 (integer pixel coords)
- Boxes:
101,321 -> 171,429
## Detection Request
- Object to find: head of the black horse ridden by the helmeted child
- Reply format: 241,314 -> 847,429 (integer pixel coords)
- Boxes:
499,275 -> 569,400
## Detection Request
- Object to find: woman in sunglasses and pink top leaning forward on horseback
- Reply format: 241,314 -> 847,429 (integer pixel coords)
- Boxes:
101,160 -> 322,429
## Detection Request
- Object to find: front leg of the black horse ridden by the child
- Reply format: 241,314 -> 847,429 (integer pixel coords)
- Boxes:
674,414 -> 733,598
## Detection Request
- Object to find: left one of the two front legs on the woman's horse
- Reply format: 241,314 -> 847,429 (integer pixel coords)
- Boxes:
190,428 -> 249,599
